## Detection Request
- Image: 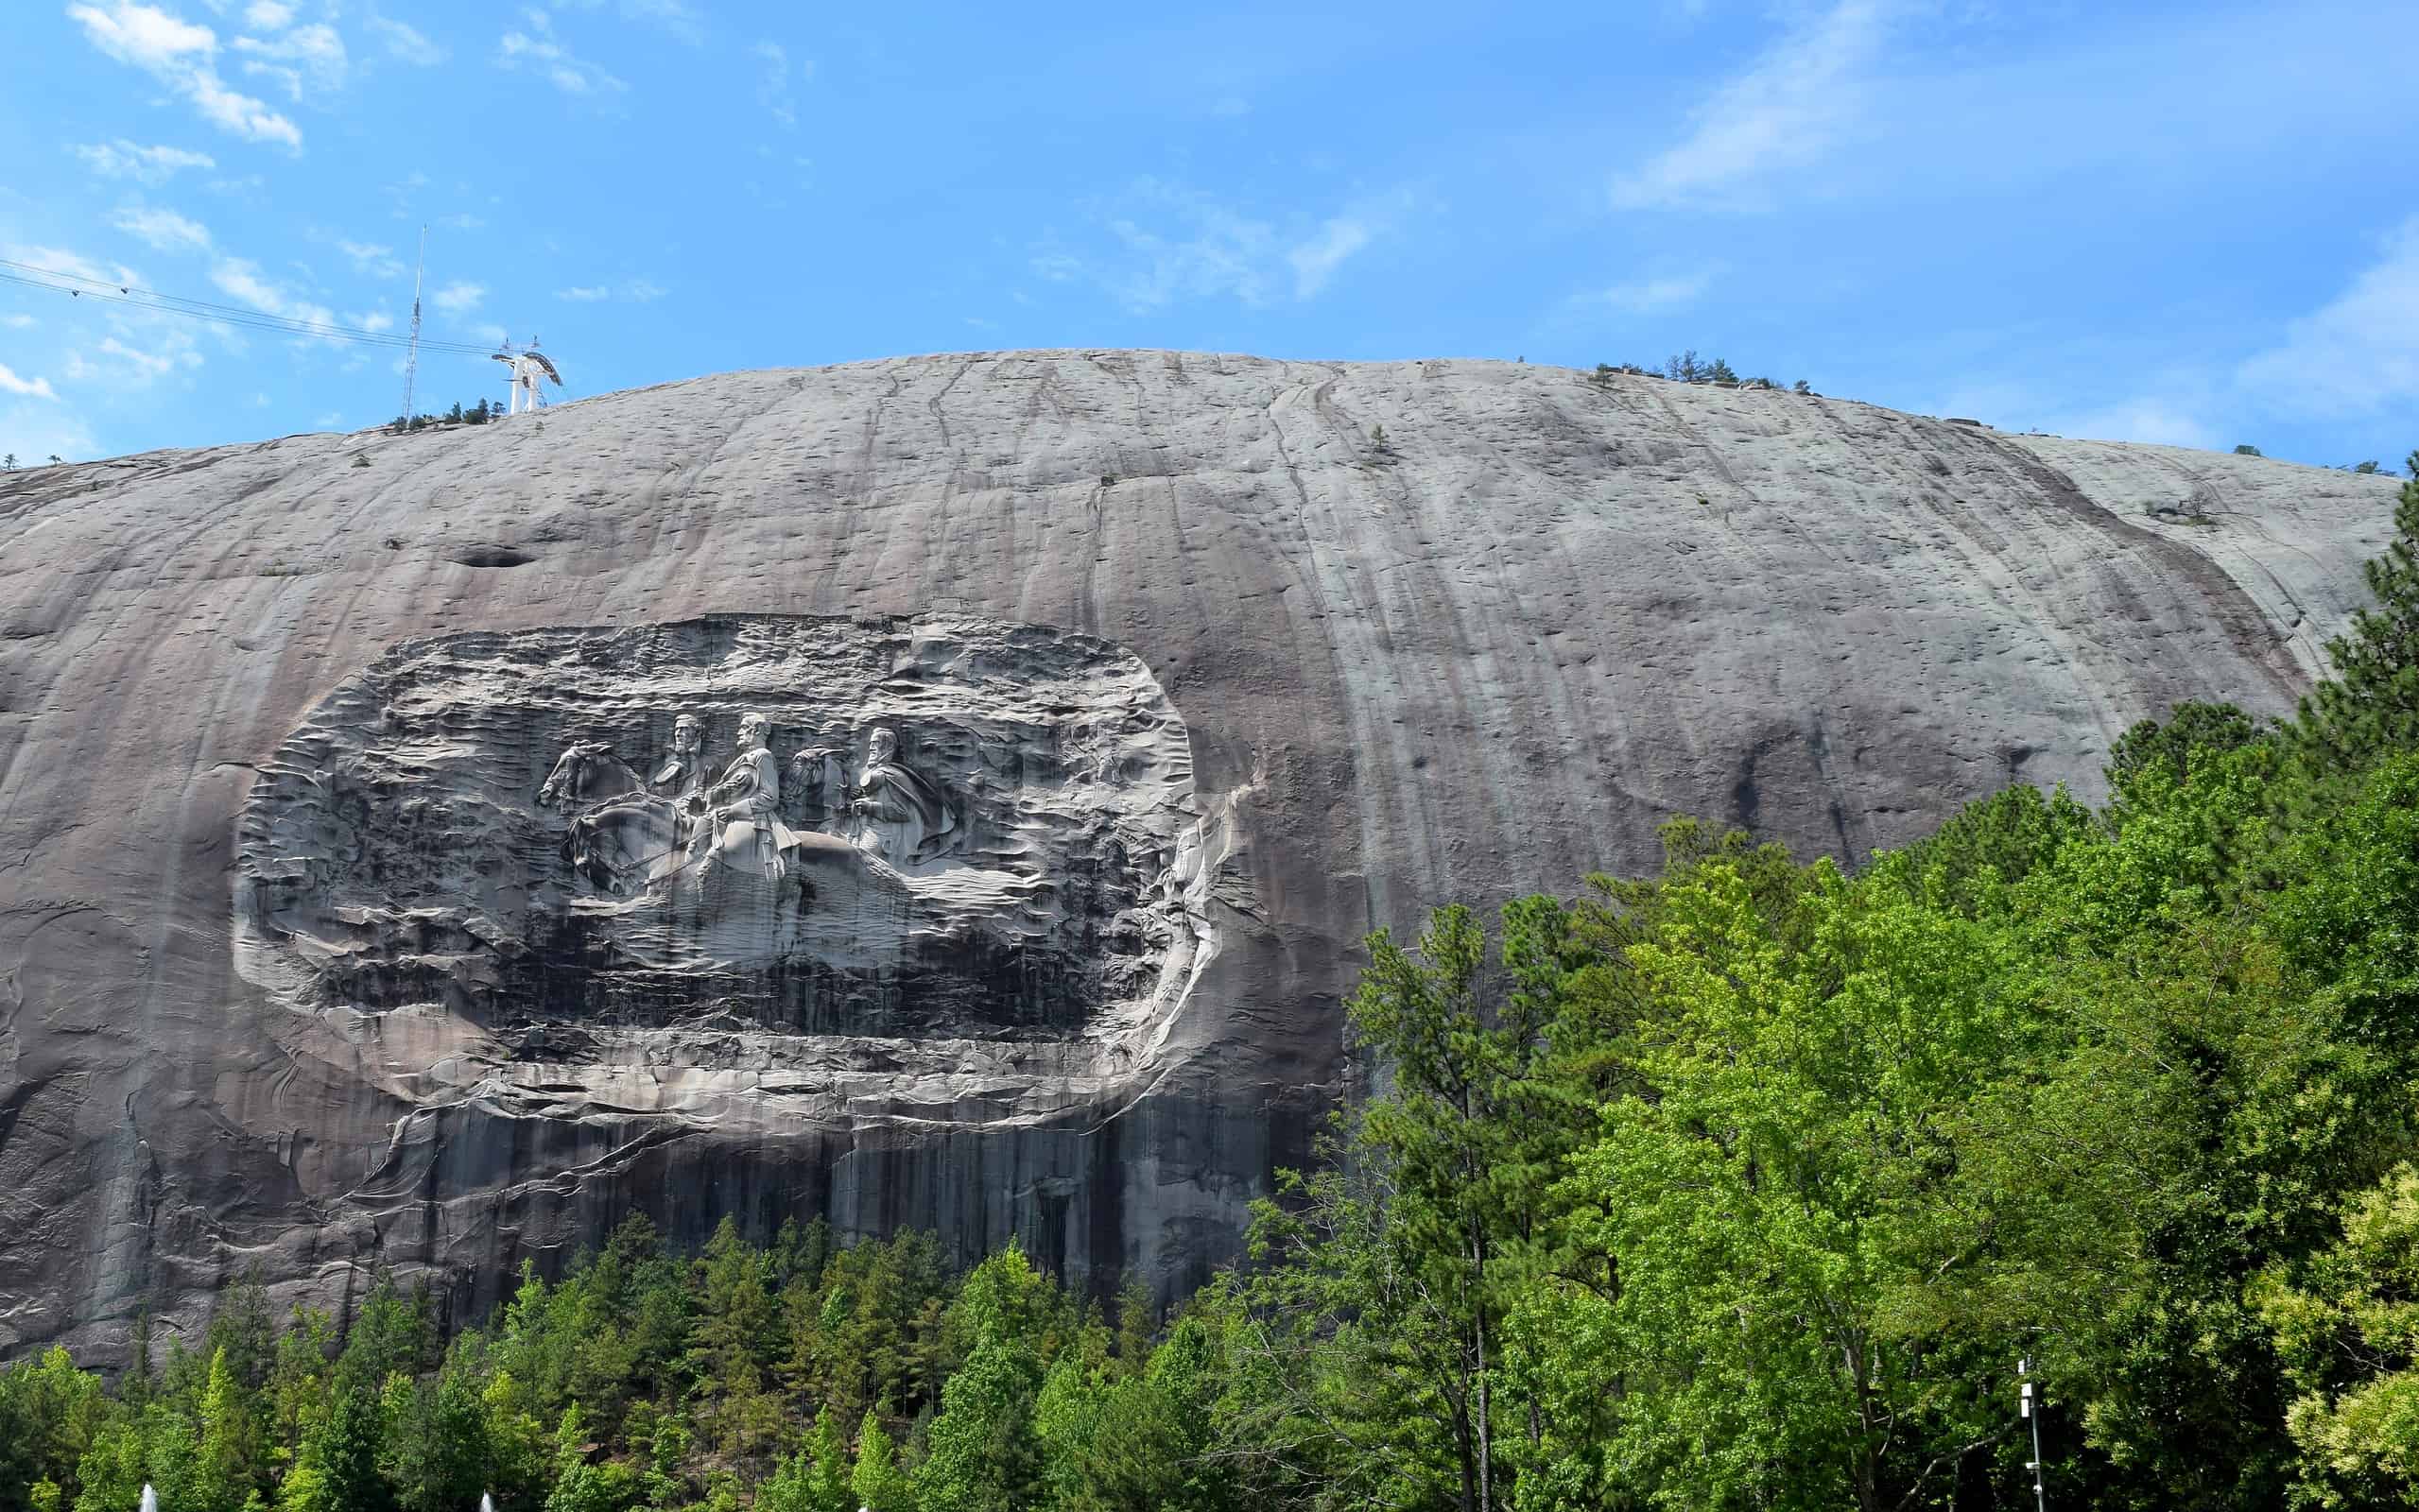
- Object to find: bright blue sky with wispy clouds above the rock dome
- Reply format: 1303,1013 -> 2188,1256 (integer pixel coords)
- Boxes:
0,0 -> 2419,465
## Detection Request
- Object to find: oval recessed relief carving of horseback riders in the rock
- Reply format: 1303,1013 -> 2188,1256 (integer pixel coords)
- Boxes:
237,614 -> 1228,1112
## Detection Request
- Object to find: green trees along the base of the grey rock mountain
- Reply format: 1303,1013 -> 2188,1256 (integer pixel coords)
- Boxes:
0,450 -> 2419,1512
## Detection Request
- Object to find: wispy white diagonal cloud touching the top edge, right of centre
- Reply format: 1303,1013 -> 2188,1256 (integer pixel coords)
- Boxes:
1614,0 -> 1899,211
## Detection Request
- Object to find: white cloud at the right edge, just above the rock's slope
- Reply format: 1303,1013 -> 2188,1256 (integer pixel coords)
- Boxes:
2236,215 -> 2419,416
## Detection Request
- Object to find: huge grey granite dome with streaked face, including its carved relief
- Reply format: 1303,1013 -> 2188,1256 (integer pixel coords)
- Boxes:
0,353 -> 2393,1352
